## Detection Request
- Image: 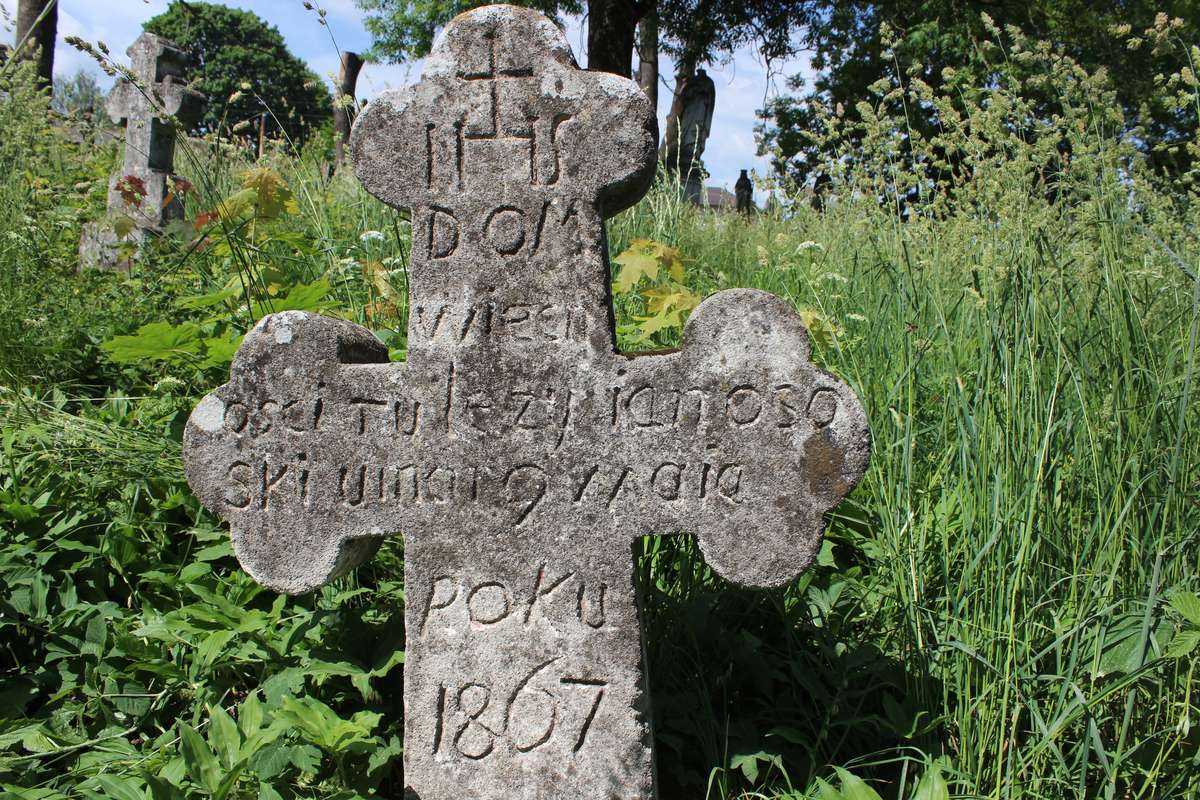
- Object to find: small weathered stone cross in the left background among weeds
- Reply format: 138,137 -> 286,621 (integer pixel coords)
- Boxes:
79,34 -> 204,269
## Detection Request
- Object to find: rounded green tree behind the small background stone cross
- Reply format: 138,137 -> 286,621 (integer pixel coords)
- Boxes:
145,0 -> 332,139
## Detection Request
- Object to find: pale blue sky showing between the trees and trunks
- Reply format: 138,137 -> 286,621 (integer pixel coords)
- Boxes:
0,0 -> 808,191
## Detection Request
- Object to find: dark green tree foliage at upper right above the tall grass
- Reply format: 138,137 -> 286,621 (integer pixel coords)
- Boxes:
762,0 -> 1200,181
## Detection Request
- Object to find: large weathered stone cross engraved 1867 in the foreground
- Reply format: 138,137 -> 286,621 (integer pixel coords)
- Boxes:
184,6 -> 870,800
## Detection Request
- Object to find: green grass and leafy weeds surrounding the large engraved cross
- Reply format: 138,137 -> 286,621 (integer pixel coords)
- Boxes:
0,32 -> 1200,800
